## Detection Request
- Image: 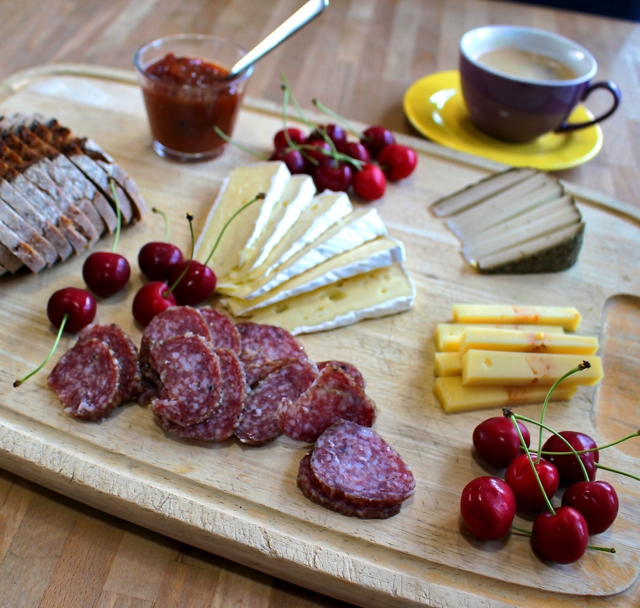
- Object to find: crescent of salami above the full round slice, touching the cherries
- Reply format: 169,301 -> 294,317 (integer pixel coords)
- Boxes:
140,306 -> 211,384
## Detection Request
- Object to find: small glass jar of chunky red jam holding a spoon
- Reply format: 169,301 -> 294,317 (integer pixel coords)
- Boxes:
142,53 -> 245,160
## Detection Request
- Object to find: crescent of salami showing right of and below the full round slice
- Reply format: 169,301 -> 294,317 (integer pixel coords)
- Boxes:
161,348 -> 247,441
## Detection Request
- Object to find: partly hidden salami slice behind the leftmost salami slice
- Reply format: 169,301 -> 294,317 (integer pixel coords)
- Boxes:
78,323 -> 142,404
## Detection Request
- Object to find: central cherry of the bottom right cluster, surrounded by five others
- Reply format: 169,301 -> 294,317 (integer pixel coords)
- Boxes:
504,452 -> 559,513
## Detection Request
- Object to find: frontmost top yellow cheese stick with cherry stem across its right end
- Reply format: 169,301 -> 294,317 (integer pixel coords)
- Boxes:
462,350 -> 603,386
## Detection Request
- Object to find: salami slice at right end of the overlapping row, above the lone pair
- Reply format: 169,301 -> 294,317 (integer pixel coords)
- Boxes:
278,365 -> 376,442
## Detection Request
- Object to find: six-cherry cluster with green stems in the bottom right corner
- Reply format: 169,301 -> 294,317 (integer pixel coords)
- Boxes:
460,361 -> 640,564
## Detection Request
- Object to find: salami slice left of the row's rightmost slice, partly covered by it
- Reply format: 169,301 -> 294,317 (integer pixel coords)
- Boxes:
236,359 -> 318,446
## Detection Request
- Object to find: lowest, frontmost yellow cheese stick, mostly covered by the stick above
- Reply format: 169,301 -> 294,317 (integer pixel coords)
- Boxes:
433,376 -> 578,414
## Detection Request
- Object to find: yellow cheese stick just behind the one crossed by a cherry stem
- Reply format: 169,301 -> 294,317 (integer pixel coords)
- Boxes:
460,327 -> 598,355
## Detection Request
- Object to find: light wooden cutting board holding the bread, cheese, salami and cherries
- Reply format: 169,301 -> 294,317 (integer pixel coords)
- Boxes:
0,66 -> 640,607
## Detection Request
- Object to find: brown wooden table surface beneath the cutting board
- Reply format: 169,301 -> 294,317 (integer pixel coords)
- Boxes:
0,0 -> 640,608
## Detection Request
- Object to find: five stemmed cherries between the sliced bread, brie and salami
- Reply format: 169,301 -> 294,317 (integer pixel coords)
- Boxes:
13,183 -> 264,388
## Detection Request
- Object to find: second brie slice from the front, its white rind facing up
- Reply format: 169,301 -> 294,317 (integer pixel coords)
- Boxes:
225,237 -> 405,316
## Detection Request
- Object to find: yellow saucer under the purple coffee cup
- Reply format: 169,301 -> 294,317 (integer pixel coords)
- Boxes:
404,70 -> 602,171
